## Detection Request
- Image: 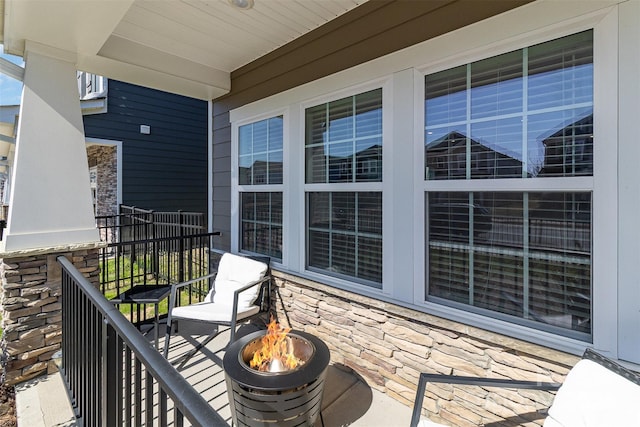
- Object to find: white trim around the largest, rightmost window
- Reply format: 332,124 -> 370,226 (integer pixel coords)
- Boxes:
414,4 -> 618,357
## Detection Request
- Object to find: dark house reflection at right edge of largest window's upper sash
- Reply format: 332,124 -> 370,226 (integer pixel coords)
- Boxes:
539,114 -> 593,176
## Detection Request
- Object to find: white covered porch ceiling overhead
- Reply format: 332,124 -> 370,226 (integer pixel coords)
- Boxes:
0,0 -> 367,100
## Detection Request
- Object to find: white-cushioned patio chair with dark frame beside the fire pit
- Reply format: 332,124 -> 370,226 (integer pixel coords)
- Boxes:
164,253 -> 271,367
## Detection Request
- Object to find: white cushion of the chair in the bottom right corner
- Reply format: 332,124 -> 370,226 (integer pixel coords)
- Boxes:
544,359 -> 640,427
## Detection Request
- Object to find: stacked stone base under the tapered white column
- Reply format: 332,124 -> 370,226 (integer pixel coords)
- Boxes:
0,243 -> 101,385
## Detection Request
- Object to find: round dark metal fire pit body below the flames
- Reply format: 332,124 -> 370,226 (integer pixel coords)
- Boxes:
223,331 -> 329,427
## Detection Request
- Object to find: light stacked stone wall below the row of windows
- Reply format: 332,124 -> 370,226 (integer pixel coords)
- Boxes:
275,272 -> 579,427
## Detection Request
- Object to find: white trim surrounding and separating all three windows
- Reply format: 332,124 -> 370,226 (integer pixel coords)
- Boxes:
230,0 -> 632,357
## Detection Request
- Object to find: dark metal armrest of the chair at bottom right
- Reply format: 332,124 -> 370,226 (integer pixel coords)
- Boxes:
411,373 -> 561,427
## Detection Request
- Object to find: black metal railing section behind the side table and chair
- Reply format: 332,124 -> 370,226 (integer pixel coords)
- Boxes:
96,205 -> 215,338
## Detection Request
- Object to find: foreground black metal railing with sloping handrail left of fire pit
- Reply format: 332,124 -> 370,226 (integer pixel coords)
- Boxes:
58,256 -> 228,427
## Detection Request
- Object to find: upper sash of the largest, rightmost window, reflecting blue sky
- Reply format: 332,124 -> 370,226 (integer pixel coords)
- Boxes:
425,31 -> 593,180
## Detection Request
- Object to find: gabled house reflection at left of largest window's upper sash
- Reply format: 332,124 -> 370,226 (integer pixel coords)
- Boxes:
425,131 -> 522,179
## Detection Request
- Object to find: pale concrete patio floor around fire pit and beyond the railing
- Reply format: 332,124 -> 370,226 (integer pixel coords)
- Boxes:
16,324 -> 411,427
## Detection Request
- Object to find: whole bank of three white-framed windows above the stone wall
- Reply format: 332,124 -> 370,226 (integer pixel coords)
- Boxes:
231,2 -> 624,361
